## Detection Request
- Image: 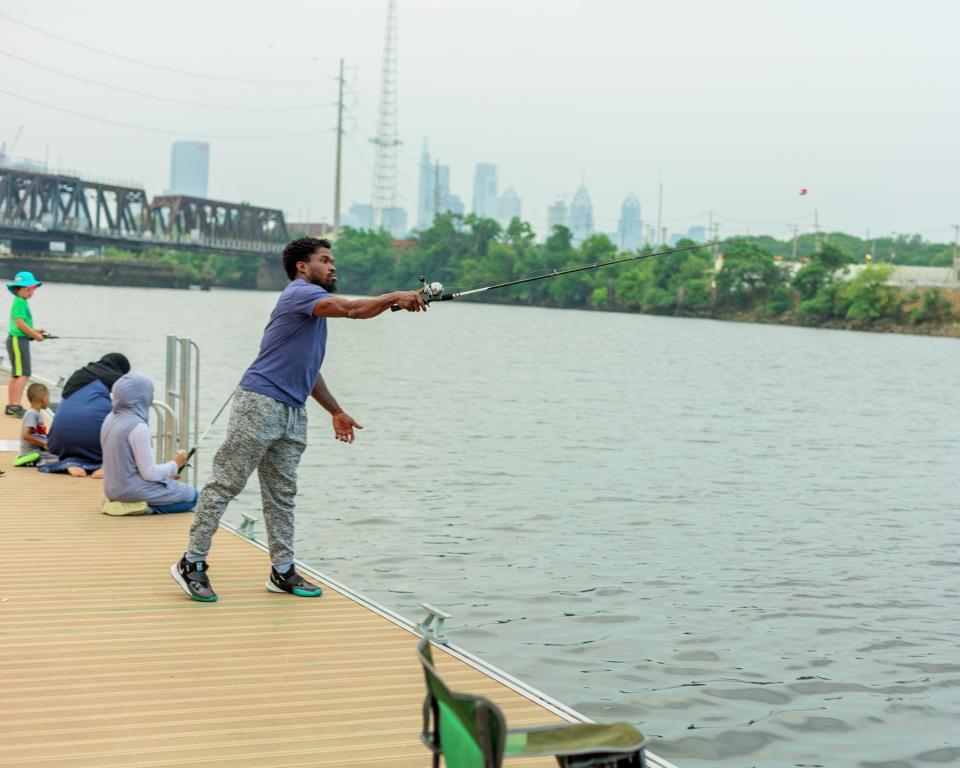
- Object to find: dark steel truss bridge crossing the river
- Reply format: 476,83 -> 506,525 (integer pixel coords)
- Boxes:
0,168 -> 289,256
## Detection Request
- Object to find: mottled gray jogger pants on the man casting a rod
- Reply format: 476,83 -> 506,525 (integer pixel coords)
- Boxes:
189,389 -> 307,564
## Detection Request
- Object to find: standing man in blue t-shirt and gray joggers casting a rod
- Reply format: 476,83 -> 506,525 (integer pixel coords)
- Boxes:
170,237 -> 427,603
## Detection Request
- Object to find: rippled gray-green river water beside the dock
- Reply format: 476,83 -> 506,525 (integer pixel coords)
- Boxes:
22,285 -> 960,768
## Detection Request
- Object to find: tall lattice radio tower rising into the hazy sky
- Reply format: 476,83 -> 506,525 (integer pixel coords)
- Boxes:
371,0 -> 400,229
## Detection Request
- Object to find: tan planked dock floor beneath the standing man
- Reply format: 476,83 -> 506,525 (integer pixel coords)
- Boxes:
0,390 -> 663,768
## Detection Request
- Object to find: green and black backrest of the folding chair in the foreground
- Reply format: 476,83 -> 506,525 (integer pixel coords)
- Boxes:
417,638 -> 507,768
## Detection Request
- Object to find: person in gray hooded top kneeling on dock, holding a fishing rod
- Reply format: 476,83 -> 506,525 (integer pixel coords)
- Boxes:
100,373 -> 197,514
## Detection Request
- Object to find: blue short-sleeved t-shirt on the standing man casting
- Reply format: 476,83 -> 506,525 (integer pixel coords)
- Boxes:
240,278 -> 330,408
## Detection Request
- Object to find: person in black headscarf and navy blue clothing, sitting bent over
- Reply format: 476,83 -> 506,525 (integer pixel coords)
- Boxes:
41,352 -> 130,477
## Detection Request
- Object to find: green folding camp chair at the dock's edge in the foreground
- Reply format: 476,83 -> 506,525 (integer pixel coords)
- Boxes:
417,638 -> 647,768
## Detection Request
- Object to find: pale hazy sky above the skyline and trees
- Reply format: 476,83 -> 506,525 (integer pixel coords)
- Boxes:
0,0 -> 960,240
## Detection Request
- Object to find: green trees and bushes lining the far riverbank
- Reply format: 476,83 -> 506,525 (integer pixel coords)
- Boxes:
9,214 -> 960,337
